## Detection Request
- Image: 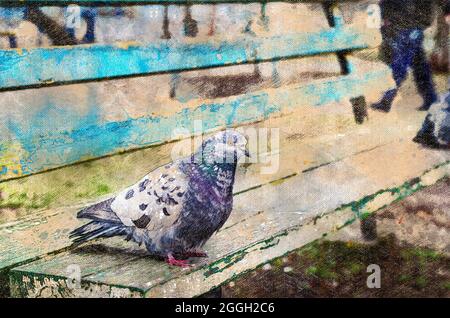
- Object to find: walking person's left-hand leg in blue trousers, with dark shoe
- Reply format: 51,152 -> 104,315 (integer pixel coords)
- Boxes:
372,31 -> 414,112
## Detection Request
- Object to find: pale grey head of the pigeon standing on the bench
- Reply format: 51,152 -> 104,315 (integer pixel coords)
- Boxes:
197,130 -> 249,164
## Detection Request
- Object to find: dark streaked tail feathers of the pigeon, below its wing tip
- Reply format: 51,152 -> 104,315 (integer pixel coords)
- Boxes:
69,221 -> 128,245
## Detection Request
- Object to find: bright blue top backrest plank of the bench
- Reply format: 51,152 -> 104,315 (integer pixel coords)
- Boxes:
0,27 -> 376,89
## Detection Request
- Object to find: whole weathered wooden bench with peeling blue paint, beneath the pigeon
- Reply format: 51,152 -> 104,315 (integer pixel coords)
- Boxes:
0,0 -> 444,297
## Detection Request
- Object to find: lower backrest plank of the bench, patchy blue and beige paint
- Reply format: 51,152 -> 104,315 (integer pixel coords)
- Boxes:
0,59 -> 393,180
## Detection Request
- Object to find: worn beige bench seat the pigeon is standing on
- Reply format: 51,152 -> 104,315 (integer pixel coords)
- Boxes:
6,108 -> 450,297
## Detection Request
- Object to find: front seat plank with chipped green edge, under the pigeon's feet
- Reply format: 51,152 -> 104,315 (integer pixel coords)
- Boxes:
11,140 -> 450,297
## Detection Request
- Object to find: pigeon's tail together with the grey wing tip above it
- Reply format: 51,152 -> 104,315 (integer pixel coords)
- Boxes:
69,199 -> 128,245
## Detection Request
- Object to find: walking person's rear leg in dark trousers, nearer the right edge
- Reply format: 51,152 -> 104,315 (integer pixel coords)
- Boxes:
412,31 -> 437,111
